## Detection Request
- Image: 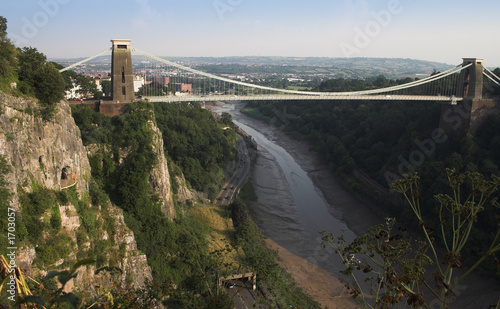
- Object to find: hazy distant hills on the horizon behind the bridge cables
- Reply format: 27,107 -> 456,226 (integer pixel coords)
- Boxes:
50,54 -> 453,78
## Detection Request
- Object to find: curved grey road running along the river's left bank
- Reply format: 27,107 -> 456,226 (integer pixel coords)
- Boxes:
215,134 -> 250,204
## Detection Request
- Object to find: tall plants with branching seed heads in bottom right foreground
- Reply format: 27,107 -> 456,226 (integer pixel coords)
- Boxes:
323,169 -> 500,308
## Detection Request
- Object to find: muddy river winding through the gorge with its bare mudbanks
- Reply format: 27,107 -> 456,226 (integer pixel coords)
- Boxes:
211,103 -> 500,308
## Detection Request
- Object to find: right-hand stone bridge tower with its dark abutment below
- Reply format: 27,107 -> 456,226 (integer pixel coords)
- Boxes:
439,58 -> 496,138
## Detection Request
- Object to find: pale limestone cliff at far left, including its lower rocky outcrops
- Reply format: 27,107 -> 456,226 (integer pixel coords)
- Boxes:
0,92 -> 152,291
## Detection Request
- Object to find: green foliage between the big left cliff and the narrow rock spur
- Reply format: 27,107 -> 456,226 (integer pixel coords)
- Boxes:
72,103 -> 234,307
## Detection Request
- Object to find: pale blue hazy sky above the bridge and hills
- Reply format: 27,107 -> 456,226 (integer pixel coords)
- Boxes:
0,0 -> 500,67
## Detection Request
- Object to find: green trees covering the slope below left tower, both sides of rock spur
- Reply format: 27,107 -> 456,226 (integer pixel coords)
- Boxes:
72,102 -> 236,308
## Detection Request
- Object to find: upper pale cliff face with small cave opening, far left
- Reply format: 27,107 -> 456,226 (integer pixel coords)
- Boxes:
0,93 -> 90,210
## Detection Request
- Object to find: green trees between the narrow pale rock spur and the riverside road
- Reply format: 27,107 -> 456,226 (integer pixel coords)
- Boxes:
154,103 -> 236,198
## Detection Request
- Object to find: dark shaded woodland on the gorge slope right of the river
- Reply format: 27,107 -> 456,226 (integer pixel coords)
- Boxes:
244,96 -> 500,273
